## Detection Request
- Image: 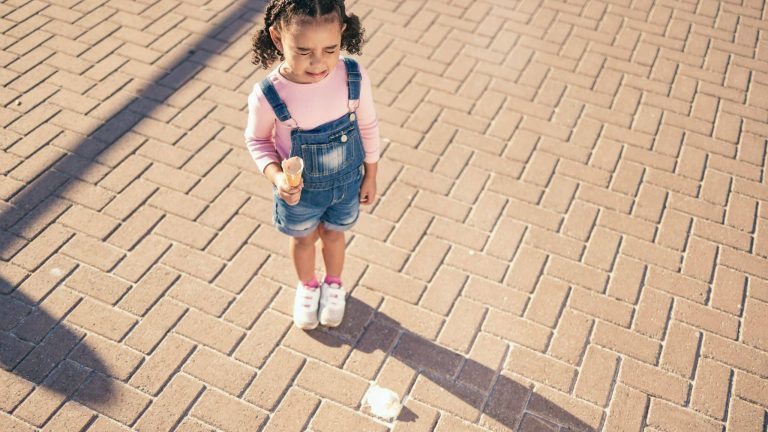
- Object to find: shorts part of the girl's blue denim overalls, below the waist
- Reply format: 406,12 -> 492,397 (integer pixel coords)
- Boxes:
272,175 -> 362,237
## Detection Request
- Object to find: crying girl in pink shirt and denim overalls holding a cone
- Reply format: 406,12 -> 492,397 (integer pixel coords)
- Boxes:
245,0 -> 379,329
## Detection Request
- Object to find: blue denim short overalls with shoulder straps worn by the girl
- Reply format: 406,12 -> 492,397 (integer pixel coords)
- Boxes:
259,58 -> 365,237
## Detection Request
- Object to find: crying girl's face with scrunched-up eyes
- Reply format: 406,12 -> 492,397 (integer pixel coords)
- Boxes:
269,16 -> 343,84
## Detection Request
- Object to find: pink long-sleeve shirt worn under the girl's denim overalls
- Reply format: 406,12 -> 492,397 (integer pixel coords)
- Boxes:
245,58 -> 380,172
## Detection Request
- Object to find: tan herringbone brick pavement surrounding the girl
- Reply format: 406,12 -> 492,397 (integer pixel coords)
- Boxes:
0,0 -> 768,432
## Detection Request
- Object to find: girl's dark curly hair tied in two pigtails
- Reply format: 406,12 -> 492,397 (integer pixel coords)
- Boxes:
251,0 -> 365,69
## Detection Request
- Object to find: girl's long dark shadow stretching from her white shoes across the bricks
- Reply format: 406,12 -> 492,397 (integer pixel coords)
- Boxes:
306,296 -> 600,431
